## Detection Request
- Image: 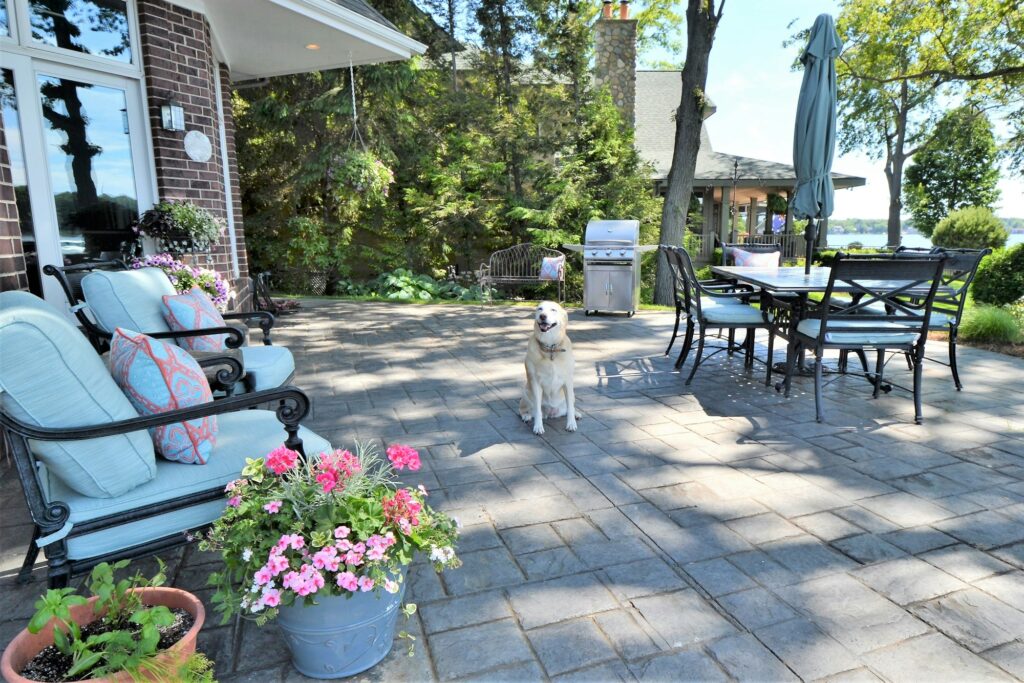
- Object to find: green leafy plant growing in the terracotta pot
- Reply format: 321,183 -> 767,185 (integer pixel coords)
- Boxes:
28,560 -> 174,679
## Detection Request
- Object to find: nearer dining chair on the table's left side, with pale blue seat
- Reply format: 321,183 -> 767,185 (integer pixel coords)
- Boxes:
663,247 -> 769,385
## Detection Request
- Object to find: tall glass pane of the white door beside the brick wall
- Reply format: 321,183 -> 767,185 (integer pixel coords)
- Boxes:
38,75 -> 138,264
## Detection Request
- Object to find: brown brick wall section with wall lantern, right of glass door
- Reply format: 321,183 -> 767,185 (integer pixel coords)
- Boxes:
138,0 -> 251,309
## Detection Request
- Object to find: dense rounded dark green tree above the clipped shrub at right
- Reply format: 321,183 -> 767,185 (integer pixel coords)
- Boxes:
903,106 -> 999,237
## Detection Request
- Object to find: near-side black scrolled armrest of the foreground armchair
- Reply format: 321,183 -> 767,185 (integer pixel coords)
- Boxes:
0,386 -> 309,453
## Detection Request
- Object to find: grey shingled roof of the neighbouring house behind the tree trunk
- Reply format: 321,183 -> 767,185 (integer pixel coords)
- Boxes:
636,71 -> 864,187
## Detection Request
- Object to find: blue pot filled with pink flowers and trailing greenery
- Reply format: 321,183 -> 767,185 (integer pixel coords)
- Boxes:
201,445 -> 461,678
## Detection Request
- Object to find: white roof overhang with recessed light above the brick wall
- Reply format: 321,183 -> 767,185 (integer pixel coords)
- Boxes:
171,0 -> 426,81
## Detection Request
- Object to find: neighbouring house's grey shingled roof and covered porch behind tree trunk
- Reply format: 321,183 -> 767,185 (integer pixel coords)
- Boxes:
636,71 -> 864,257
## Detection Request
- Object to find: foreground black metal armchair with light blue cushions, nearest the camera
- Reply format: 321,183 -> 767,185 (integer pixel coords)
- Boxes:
0,292 -> 331,587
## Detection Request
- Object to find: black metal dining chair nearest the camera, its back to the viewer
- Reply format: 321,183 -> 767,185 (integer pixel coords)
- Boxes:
784,252 -> 945,424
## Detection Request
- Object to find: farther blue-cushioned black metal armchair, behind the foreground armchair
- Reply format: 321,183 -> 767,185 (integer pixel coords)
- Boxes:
43,261 -> 295,391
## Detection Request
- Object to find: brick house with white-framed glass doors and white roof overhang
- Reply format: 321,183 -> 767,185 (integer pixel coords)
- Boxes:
0,0 -> 425,309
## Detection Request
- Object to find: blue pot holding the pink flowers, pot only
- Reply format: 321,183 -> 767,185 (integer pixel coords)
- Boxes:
278,582 -> 406,678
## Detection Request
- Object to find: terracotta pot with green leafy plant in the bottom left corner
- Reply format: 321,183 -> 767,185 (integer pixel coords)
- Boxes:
0,560 -> 211,683
